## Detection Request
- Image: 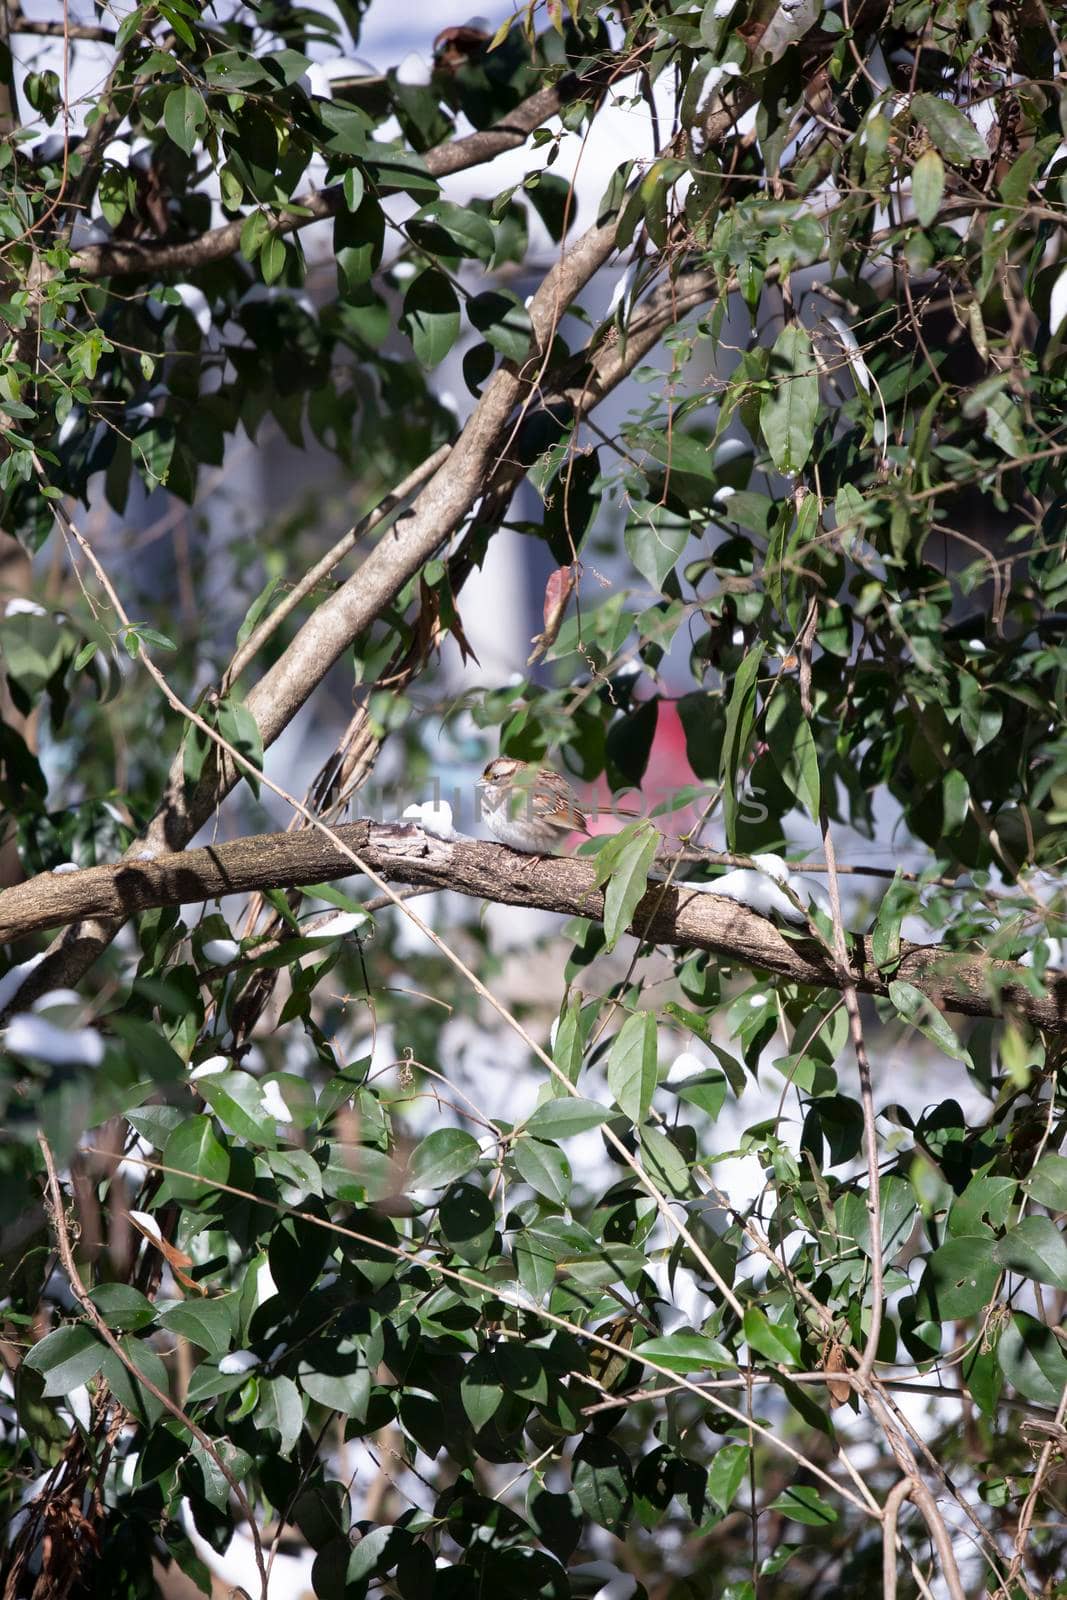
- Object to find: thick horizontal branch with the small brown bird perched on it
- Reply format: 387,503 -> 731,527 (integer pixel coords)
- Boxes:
0,822 -> 1067,1032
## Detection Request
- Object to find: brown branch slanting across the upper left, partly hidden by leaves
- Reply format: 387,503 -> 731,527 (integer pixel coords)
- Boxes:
70,64 -> 607,278
